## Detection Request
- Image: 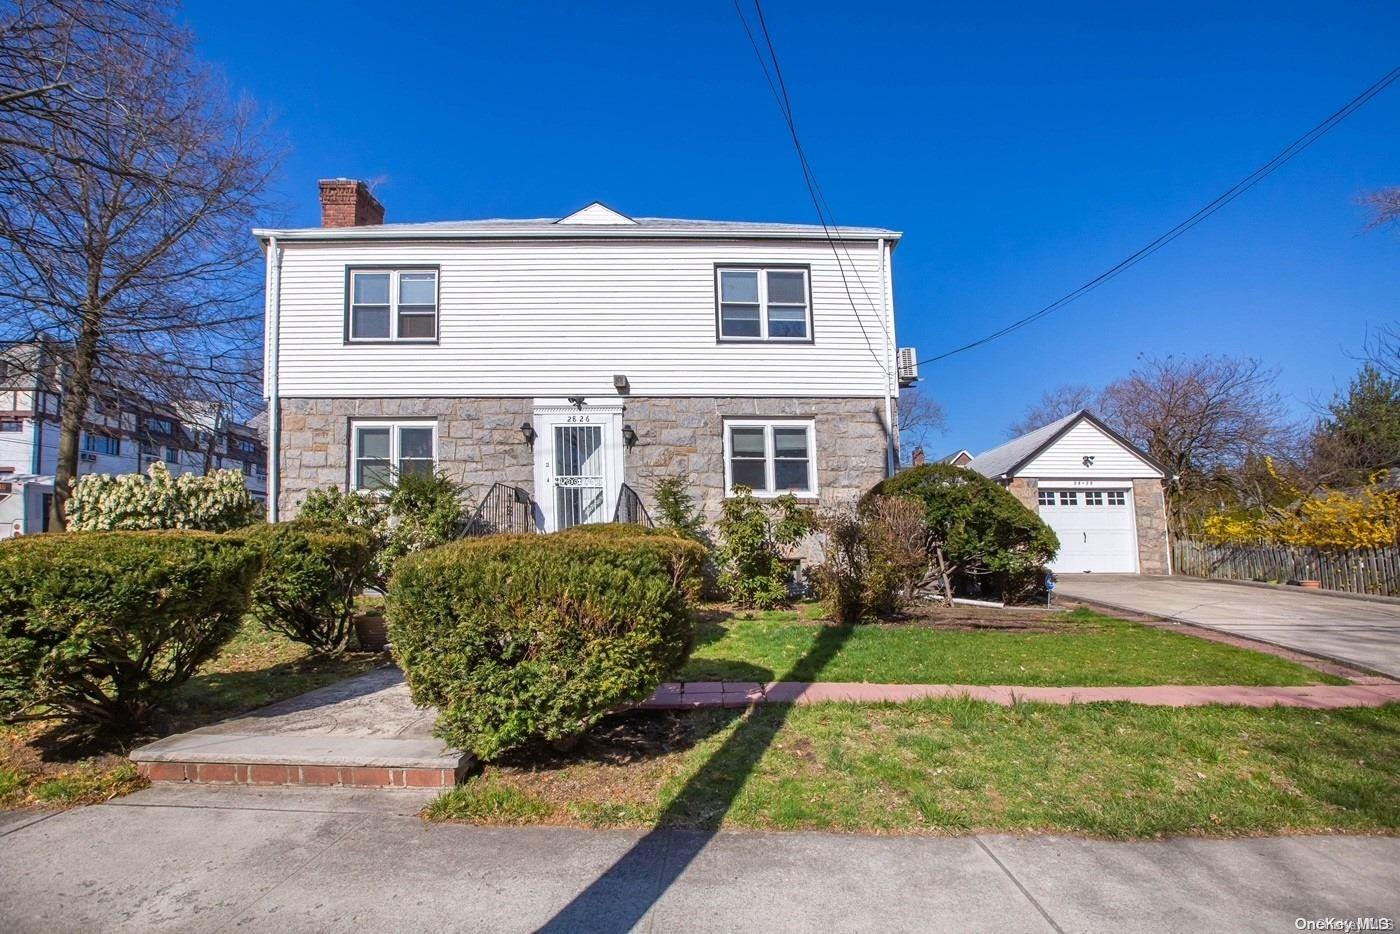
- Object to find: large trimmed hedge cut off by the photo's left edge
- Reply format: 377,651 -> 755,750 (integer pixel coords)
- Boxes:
0,531 -> 260,734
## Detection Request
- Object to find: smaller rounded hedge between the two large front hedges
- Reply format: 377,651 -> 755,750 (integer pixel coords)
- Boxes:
239,520 -> 375,653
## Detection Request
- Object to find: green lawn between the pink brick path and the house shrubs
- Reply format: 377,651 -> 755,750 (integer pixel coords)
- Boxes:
676,609 -> 1347,686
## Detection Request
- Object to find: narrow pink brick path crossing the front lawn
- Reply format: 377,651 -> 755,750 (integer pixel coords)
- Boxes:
640,678 -> 1400,710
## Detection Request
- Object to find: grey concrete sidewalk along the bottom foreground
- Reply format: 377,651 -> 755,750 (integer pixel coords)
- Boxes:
0,786 -> 1400,933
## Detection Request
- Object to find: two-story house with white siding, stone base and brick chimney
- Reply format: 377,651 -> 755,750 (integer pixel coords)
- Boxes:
255,179 -> 914,529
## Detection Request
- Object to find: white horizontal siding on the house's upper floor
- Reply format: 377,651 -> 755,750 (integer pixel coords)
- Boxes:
267,239 -> 892,399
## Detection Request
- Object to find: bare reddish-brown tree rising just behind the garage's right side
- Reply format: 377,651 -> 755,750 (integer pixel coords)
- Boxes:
1099,356 -> 1285,529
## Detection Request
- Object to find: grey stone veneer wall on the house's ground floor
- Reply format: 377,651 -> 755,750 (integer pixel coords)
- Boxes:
279,396 -> 885,521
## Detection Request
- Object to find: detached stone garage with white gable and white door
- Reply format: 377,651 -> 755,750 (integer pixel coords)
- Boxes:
967,410 -> 1172,574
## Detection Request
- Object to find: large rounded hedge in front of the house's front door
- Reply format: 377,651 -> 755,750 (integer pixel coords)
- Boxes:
386,527 -> 704,760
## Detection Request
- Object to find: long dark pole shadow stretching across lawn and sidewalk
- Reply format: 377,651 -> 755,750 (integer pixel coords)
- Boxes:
539,616 -> 851,931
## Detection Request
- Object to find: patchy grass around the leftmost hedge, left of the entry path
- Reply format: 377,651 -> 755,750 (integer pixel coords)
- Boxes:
0,623 -> 384,809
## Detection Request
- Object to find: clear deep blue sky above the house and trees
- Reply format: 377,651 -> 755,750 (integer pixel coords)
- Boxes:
185,0 -> 1400,451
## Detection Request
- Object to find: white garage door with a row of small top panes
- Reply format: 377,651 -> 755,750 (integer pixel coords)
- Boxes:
1039,487 -> 1137,574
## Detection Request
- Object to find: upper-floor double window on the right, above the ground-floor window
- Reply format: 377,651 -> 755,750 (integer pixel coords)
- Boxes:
715,266 -> 812,340
